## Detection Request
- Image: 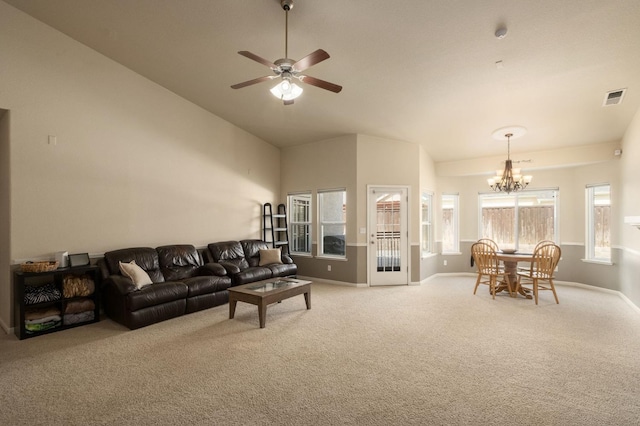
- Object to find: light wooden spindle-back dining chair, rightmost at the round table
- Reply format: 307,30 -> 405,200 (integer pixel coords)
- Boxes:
516,244 -> 562,305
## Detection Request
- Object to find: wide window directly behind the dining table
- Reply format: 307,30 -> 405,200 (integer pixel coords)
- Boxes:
478,189 -> 558,253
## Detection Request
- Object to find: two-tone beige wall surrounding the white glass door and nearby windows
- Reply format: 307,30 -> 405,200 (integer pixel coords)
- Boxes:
281,135 -> 435,284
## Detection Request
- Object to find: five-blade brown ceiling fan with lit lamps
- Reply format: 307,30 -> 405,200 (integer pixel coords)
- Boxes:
231,0 -> 342,105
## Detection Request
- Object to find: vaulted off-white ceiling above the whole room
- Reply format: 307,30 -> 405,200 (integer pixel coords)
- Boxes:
4,0 -> 640,161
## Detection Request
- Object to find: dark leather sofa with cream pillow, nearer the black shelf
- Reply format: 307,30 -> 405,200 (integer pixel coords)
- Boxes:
98,245 -> 231,330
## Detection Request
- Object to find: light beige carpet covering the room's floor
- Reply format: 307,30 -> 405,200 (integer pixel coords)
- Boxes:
0,276 -> 640,425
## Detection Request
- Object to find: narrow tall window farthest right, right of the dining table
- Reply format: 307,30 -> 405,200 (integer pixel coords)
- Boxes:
585,184 -> 611,262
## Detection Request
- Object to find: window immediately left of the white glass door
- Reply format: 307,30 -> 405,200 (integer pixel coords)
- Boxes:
318,189 -> 347,257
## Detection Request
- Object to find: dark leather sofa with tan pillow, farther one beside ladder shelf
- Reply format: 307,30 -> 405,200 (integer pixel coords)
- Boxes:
207,240 -> 298,286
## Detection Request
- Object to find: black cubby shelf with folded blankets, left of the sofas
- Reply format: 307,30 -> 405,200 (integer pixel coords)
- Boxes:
13,265 -> 100,340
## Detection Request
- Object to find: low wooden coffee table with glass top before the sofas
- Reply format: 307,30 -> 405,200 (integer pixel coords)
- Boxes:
229,278 -> 311,328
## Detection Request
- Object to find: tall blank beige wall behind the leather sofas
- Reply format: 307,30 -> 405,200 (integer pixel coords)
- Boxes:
0,2 -> 280,328
